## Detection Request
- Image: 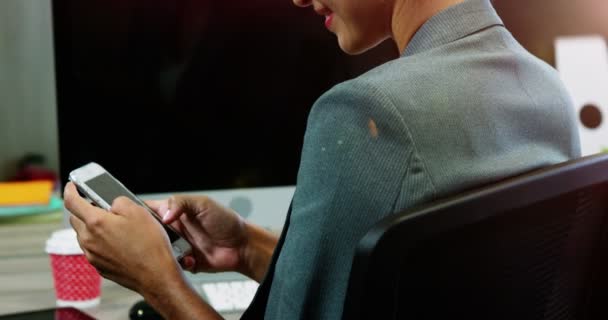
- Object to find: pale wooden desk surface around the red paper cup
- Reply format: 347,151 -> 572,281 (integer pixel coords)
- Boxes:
0,222 -> 240,320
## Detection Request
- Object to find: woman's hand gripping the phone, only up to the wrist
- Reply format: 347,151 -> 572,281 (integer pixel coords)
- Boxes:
64,183 -> 183,294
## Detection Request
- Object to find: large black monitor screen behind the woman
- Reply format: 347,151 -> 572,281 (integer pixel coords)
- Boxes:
53,0 -> 398,194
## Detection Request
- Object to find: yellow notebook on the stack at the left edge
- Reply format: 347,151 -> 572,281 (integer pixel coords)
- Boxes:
0,180 -> 53,207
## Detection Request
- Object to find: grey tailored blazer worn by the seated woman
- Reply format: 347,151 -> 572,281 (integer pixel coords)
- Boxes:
242,0 -> 580,319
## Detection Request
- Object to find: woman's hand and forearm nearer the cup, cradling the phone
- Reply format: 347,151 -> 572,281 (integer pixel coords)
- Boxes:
64,183 -> 226,320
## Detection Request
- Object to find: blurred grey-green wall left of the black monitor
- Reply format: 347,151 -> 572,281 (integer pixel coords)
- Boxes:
0,0 -> 59,181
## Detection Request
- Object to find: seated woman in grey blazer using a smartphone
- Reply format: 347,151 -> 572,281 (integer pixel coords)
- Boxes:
65,0 -> 579,319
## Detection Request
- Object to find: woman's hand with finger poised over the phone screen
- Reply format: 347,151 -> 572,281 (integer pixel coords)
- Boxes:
146,196 -> 277,281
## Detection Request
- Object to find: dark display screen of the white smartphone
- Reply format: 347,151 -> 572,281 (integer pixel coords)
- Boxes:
85,173 -> 180,243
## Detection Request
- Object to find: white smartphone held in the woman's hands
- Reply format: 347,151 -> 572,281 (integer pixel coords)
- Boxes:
70,162 -> 192,261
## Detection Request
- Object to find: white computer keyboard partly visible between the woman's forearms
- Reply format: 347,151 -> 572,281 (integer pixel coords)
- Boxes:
201,280 -> 258,312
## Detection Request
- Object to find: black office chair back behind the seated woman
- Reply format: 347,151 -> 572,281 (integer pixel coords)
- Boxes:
343,155 -> 608,320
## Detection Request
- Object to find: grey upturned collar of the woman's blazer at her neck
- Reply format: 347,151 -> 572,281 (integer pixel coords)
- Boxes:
402,0 -> 504,57
